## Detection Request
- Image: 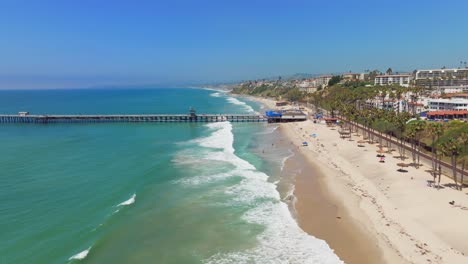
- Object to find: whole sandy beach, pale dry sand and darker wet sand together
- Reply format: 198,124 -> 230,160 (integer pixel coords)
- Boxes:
256,98 -> 468,263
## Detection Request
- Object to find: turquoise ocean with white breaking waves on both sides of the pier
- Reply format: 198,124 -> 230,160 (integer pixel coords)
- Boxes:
0,89 -> 340,264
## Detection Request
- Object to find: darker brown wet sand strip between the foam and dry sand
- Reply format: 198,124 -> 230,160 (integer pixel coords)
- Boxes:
282,130 -> 384,264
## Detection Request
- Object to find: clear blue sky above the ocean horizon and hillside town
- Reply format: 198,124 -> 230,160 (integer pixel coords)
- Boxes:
0,0 -> 468,89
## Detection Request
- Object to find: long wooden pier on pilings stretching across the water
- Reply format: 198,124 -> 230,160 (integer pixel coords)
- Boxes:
0,114 -> 268,124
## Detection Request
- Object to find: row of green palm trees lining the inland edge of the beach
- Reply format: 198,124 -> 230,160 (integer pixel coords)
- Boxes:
309,86 -> 468,190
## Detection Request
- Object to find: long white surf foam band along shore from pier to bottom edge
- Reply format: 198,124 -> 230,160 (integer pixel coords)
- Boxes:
174,122 -> 342,264
